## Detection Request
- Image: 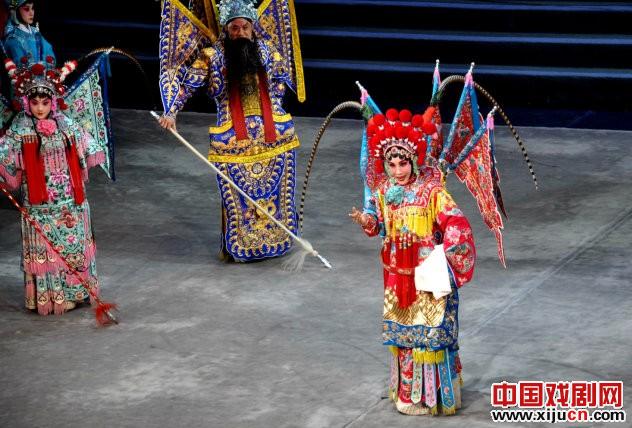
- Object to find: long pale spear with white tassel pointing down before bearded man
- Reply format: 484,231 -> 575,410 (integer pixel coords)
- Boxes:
150,111 -> 332,271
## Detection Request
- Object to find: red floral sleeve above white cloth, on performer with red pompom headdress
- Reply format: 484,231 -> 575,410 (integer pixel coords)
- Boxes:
434,189 -> 476,287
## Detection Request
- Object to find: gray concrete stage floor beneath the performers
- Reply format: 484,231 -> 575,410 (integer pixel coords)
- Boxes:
0,110 -> 632,427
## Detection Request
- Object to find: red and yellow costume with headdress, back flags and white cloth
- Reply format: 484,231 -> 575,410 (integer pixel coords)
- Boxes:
350,61 -> 520,415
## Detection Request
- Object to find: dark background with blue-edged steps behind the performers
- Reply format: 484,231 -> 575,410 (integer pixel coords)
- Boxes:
36,0 -> 632,129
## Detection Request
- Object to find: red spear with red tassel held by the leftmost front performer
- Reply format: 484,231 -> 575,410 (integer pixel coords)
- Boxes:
0,183 -> 118,327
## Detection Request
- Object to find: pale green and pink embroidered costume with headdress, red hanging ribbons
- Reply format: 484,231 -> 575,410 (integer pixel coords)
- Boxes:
0,56 -> 108,315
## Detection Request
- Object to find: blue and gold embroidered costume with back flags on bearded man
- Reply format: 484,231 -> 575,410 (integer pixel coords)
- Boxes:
161,0 -> 304,261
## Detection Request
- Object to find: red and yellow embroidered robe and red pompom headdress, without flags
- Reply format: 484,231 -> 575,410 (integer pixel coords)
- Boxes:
363,110 -> 476,414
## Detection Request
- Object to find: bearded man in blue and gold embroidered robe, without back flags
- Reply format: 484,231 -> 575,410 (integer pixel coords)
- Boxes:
160,0 -> 299,262
